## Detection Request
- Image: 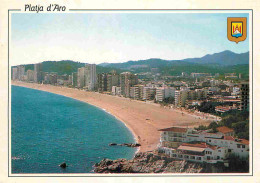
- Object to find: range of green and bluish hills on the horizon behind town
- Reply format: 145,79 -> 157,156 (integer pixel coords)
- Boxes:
13,51 -> 249,77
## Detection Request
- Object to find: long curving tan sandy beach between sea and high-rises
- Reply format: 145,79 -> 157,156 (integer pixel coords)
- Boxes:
12,81 -> 212,152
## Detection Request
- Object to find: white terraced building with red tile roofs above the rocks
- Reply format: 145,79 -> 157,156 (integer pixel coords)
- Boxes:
158,127 -> 249,163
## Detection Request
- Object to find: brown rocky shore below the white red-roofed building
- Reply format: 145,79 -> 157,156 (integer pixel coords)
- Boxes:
94,153 -> 206,173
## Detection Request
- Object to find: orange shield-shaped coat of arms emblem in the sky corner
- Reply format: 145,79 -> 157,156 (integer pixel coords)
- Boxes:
227,17 -> 247,43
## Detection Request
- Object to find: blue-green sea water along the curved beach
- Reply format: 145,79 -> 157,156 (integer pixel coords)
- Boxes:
11,86 -> 136,173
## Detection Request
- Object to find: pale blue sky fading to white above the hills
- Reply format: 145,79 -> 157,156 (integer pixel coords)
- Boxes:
10,11 -> 250,66
